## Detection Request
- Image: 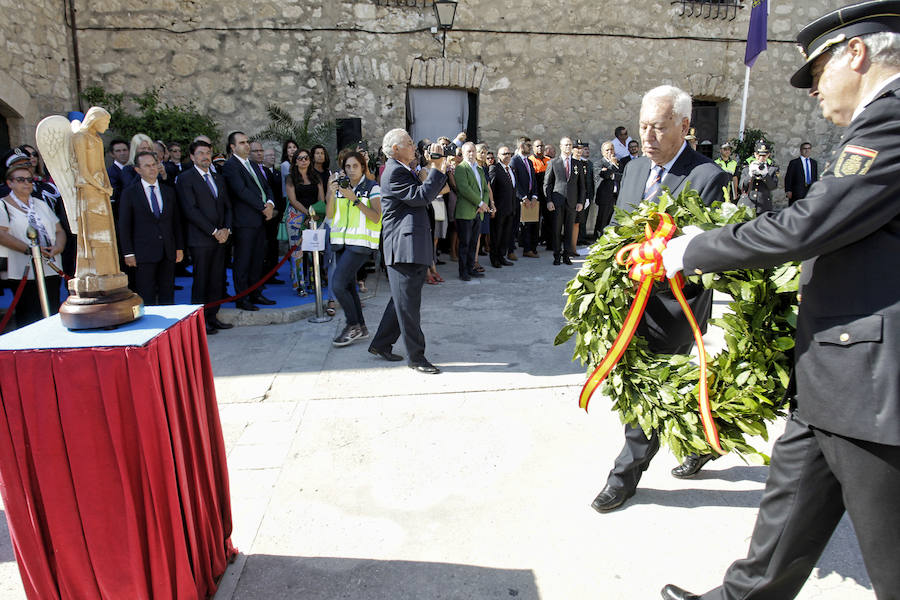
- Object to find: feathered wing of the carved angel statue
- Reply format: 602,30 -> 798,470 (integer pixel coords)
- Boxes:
35,115 -> 81,231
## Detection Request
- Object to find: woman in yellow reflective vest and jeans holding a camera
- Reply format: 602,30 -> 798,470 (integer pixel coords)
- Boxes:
326,151 -> 381,346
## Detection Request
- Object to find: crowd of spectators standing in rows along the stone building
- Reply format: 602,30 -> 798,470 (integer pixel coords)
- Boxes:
0,116 -> 818,332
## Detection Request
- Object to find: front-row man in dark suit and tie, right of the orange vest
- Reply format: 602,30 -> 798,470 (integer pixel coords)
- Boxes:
544,137 -> 585,265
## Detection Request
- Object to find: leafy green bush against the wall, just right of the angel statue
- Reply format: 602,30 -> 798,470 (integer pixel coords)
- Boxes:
81,86 -> 221,151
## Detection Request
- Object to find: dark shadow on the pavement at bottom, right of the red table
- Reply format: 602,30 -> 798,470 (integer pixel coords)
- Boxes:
234,554 -> 540,600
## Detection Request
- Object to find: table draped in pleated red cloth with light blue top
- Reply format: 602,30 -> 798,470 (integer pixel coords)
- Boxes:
0,306 -> 236,600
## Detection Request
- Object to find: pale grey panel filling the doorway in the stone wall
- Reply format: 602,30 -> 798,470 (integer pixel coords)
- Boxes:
408,88 -> 469,142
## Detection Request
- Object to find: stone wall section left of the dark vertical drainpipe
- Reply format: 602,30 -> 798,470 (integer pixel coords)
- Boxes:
0,0 -> 76,145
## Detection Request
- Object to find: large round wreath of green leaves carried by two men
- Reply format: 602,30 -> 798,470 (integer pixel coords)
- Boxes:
554,188 -> 799,464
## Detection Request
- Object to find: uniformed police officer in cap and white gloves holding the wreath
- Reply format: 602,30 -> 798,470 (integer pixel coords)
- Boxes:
662,5 -> 900,600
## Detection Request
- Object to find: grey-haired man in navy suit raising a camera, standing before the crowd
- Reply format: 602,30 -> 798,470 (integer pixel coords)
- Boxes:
369,129 -> 450,374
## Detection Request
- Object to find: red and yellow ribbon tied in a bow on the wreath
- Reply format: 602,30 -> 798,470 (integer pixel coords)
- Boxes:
578,212 -> 725,454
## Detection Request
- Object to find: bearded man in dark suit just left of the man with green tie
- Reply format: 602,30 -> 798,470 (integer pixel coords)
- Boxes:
175,141 -> 233,334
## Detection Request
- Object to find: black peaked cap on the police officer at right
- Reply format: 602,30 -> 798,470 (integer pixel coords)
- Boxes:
791,0 -> 900,88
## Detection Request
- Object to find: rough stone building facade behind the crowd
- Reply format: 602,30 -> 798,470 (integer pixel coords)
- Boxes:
0,0 -> 847,176
